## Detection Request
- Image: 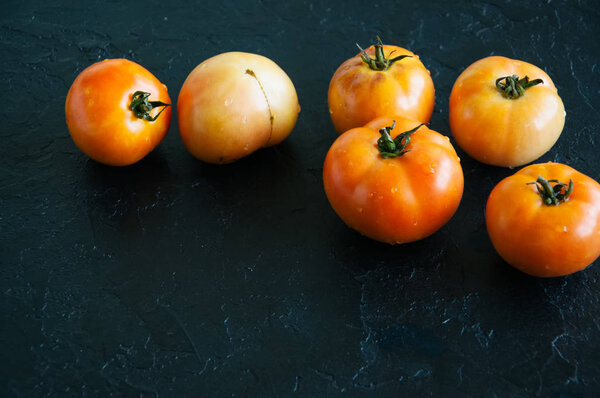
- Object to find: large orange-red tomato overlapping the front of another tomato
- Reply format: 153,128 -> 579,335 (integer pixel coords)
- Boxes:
323,117 -> 463,244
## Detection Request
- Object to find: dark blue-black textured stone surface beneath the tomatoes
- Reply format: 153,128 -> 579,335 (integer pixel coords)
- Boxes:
0,0 -> 600,397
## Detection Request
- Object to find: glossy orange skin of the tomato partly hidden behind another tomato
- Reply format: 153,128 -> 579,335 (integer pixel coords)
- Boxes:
328,45 -> 435,134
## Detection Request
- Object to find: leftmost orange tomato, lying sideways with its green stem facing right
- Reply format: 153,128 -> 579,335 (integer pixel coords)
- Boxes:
65,59 -> 171,166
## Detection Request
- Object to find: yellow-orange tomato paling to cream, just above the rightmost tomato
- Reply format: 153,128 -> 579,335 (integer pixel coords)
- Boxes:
450,57 -> 566,167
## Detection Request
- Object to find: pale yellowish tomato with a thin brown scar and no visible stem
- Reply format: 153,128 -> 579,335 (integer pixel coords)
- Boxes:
177,52 -> 300,164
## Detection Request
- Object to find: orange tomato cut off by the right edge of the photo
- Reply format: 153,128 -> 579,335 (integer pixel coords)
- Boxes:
485,162 -> 600,277
